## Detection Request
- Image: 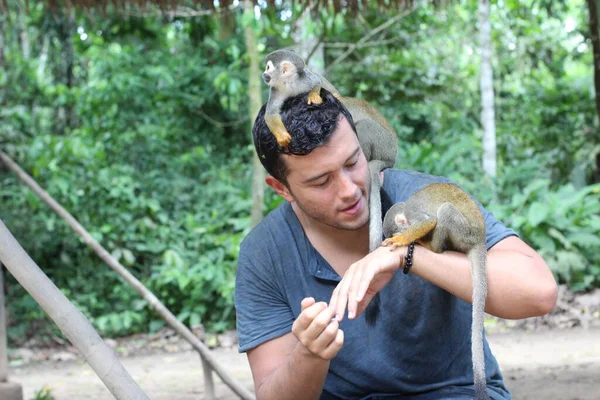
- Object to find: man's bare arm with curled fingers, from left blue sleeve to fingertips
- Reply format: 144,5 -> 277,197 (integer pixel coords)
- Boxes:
248,298 -> 344,400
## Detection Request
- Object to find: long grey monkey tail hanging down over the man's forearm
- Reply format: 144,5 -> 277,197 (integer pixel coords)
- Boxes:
468,243 -> 490,400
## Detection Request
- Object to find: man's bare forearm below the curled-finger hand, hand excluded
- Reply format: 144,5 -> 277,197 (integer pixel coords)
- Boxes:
256,343 -> 329,400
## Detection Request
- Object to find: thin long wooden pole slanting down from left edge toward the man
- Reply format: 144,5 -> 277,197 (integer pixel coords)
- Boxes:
0,151 -> 254,400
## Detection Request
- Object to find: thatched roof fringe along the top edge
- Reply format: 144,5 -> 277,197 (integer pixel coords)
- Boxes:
0,0 -> 444,13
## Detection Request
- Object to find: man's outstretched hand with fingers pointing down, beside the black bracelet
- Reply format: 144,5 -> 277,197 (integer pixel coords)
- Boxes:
329,247 -> 406,321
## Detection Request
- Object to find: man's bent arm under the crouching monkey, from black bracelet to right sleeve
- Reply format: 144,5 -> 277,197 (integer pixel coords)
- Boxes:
411,239 -> 556,319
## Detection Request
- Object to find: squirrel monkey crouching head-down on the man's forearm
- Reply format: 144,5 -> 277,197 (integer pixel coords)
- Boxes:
378,183 -> 489,400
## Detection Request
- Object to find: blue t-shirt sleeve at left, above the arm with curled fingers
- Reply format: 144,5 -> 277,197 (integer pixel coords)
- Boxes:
235,244 -> 294,352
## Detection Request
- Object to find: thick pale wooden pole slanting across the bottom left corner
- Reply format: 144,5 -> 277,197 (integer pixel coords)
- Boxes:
0,220 -> 149,400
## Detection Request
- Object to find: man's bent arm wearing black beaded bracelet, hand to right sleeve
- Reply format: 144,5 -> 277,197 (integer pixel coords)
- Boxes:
331,237 -> 558,320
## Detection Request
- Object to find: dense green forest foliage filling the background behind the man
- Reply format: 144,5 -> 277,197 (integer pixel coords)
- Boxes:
0,0 -> 600,342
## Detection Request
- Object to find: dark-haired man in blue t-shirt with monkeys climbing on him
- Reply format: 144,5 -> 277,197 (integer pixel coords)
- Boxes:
235,90 -> 557,400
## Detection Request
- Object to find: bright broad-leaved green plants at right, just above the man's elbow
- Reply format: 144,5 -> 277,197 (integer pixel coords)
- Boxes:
492,183 -> 600,291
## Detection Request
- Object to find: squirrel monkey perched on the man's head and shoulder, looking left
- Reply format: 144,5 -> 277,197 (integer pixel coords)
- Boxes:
263,50 -> 398,251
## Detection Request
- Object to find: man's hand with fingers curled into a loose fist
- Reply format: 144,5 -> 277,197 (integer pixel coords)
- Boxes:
292,297 -> 344,360
